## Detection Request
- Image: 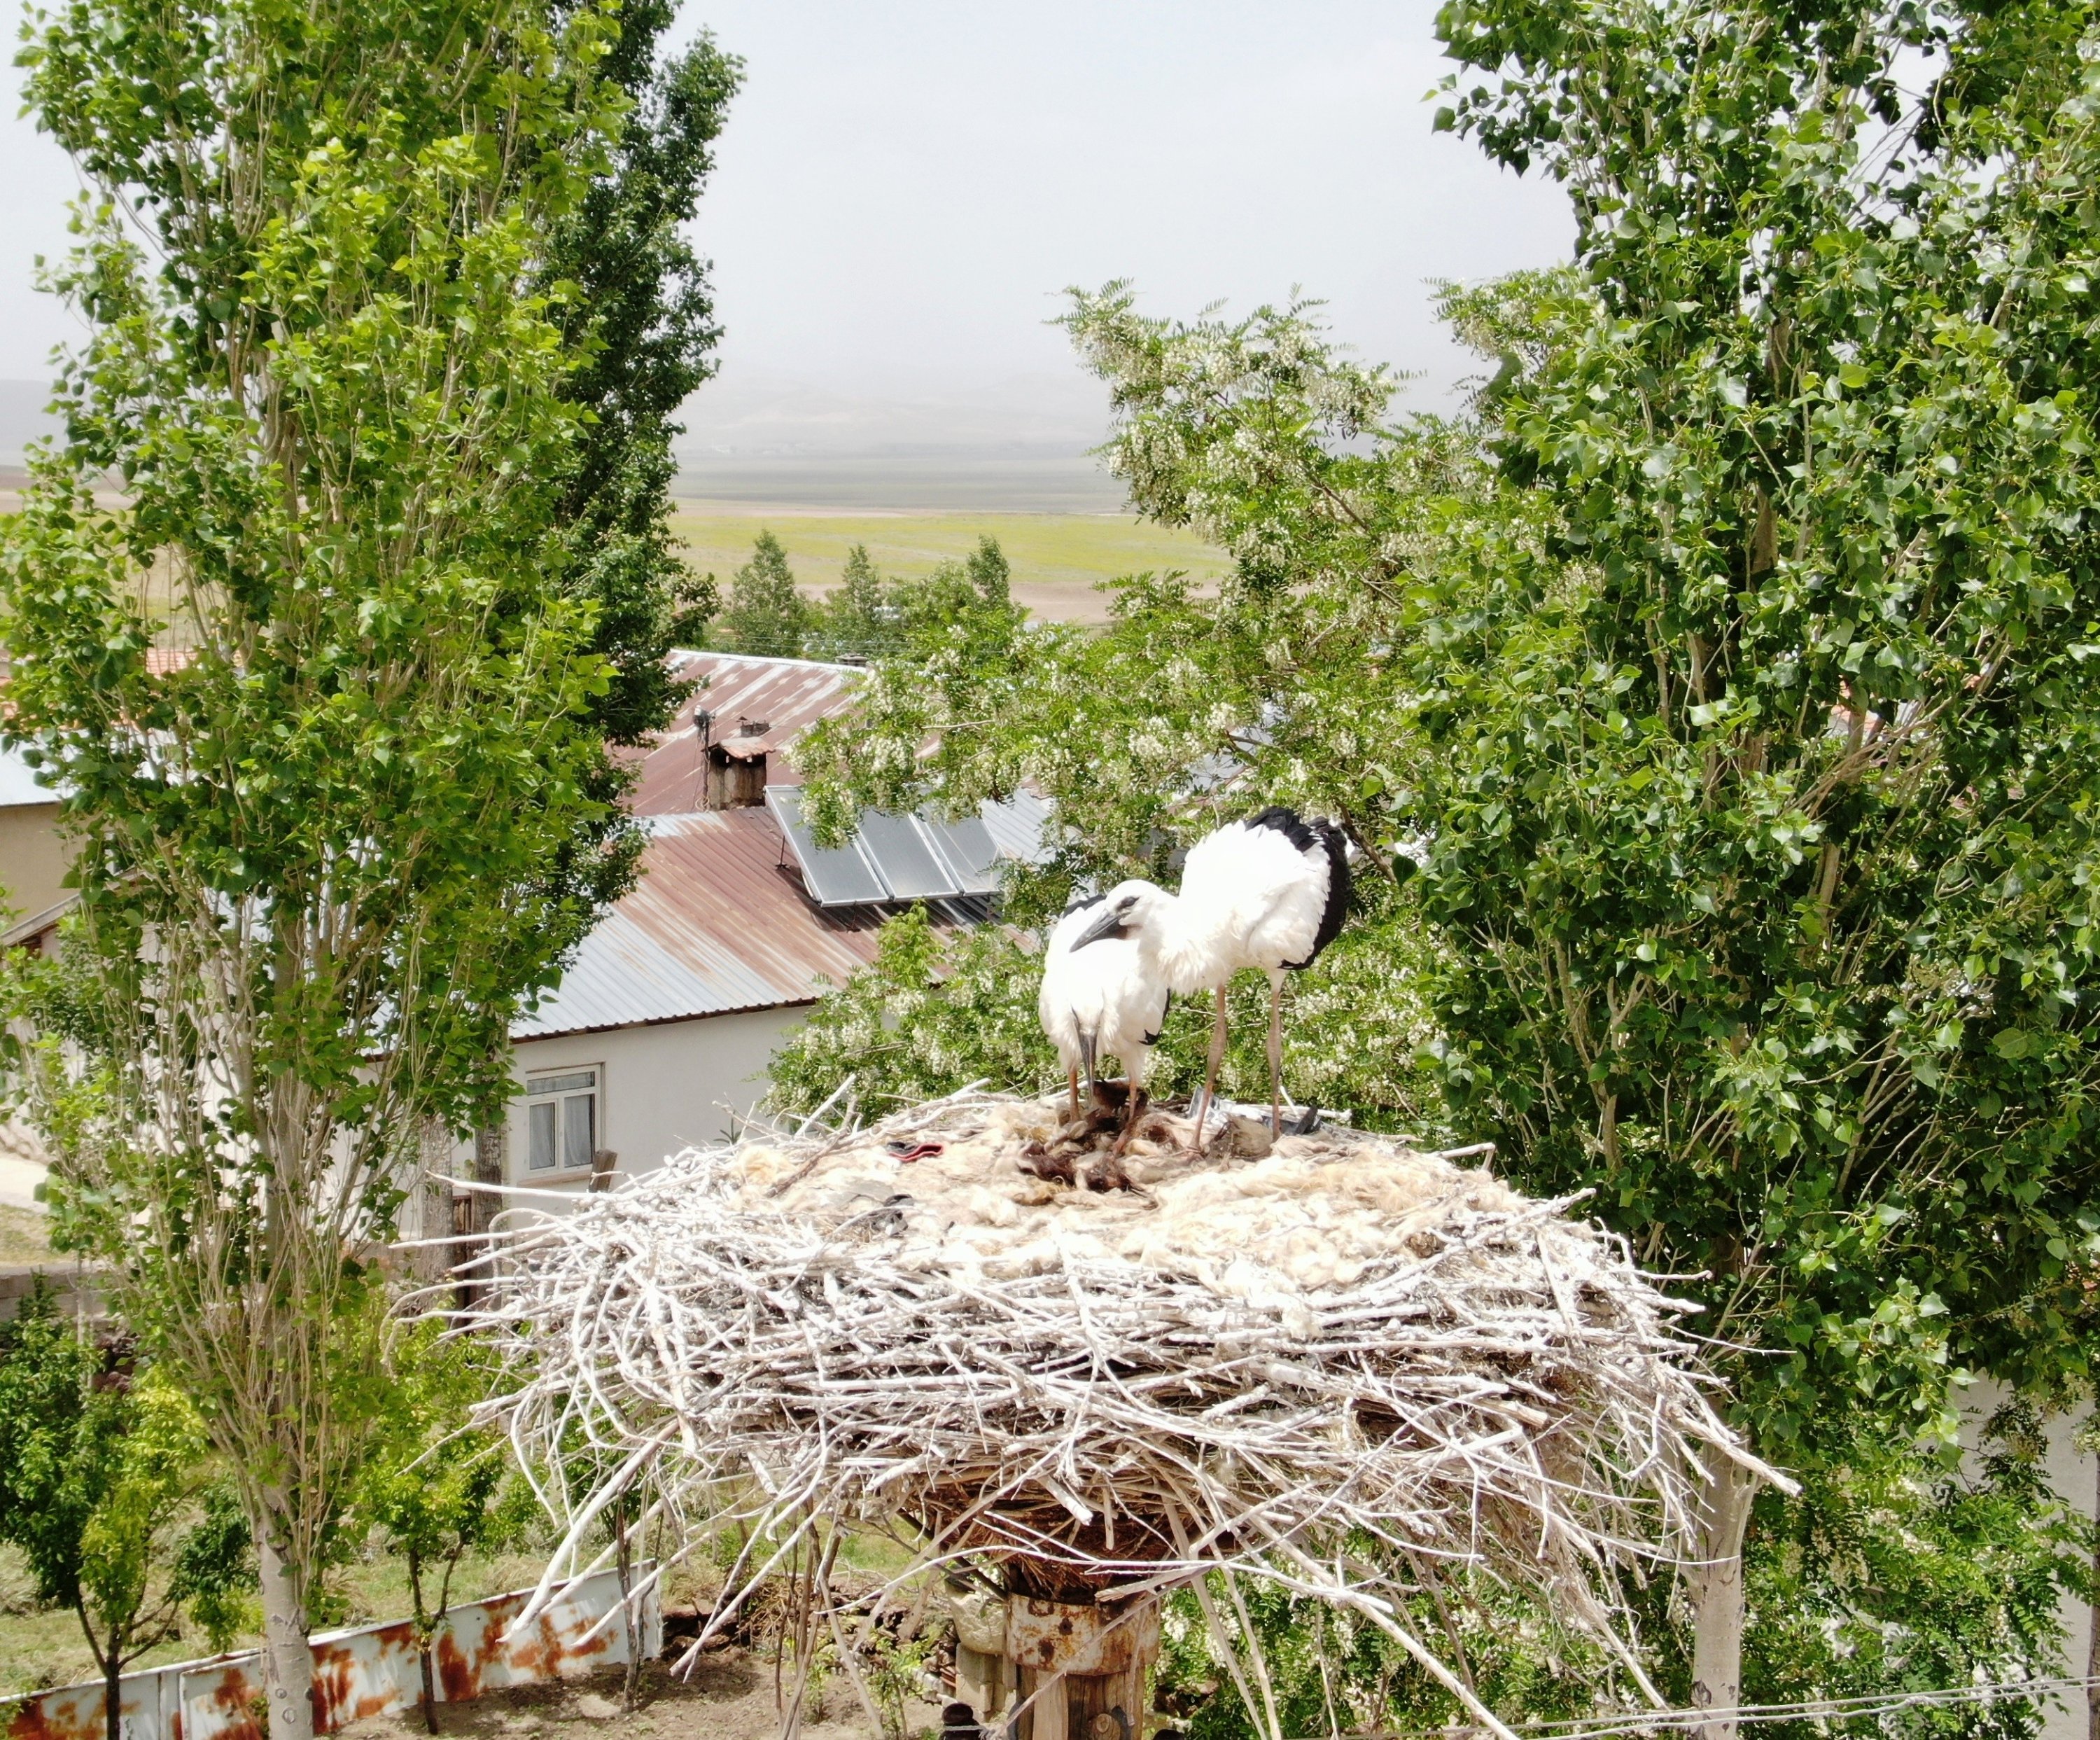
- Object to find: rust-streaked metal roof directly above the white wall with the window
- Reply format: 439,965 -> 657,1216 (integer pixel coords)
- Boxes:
510,807 -> 989,1040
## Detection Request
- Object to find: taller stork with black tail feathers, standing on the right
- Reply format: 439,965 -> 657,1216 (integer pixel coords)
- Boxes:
1071,805 -> 1348,1146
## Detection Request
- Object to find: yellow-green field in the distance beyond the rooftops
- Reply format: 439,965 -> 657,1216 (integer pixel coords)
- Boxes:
672,502 -> 1231,622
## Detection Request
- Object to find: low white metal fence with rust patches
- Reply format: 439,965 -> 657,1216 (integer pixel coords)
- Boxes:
0,1570 -> 664,1740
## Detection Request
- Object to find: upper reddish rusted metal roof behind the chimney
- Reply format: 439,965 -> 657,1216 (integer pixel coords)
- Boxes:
628,651 -> 861,815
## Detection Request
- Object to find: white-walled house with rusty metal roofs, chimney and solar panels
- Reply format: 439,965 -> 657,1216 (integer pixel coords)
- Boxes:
454,651 -> 1042,1190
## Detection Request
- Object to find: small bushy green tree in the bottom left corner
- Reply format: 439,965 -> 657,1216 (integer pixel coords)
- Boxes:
0,1288 -> 248,1740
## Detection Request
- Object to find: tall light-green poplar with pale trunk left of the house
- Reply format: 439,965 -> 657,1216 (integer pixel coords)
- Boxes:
0,0 -> 628,1740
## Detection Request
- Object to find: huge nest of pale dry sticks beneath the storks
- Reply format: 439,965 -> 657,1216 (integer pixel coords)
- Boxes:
470,1091 -> 1764,1717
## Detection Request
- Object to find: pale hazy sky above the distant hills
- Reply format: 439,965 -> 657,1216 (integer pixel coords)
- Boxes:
0,0 -> 1571,424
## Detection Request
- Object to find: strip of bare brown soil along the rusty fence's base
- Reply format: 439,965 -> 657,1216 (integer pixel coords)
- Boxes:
342,1645 -> 941,1740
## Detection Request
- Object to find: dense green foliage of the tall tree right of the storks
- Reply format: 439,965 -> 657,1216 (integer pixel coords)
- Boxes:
1405,4 -> 2100,1454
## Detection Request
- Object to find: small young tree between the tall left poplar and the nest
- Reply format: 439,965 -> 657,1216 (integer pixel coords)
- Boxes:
355,1320 -> 538,1734
